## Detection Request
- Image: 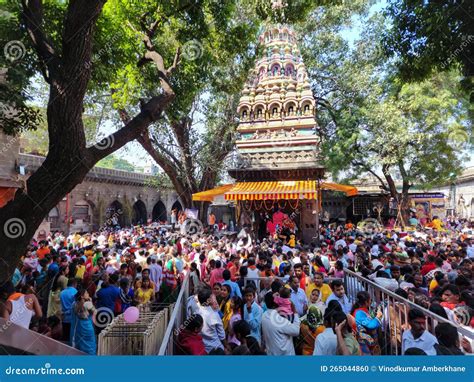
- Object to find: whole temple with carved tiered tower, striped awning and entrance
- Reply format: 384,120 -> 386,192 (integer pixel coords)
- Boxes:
193,26 -> 357,243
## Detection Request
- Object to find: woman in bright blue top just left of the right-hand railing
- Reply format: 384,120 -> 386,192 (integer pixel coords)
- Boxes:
351,291 -> 383,355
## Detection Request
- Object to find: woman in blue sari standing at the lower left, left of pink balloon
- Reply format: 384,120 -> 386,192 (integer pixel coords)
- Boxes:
71,289 -> 96,355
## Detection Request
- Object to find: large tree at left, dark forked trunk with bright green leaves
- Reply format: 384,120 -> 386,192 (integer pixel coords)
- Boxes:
0,0 -> 250,279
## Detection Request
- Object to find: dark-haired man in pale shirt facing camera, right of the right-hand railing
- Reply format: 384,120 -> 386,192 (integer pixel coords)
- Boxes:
402,309 -> 438,355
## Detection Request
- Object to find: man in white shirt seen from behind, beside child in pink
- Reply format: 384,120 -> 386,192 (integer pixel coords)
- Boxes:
262,292 -> 300,355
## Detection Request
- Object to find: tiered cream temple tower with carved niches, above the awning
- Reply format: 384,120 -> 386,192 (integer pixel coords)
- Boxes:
229,26 -> 324,181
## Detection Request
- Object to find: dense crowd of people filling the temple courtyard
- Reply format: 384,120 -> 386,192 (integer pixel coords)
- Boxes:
0,213 -> 474,355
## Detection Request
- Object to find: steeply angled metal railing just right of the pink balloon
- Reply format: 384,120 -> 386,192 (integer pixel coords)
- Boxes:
158,273 -> 190,355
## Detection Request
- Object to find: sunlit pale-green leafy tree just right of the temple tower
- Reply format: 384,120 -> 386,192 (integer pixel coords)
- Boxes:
305,7 -> 471,224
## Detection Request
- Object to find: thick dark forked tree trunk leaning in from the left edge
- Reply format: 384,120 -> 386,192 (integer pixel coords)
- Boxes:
0,0 -> 179,282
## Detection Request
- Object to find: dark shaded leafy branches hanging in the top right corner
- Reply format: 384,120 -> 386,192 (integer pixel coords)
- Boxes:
384,0 -> 474,102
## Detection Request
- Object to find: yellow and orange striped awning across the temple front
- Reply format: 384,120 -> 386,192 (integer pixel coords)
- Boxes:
193,180 -> 358,202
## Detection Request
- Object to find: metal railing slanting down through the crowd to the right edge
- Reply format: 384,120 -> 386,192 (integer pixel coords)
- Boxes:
344,269 -> 474,355
